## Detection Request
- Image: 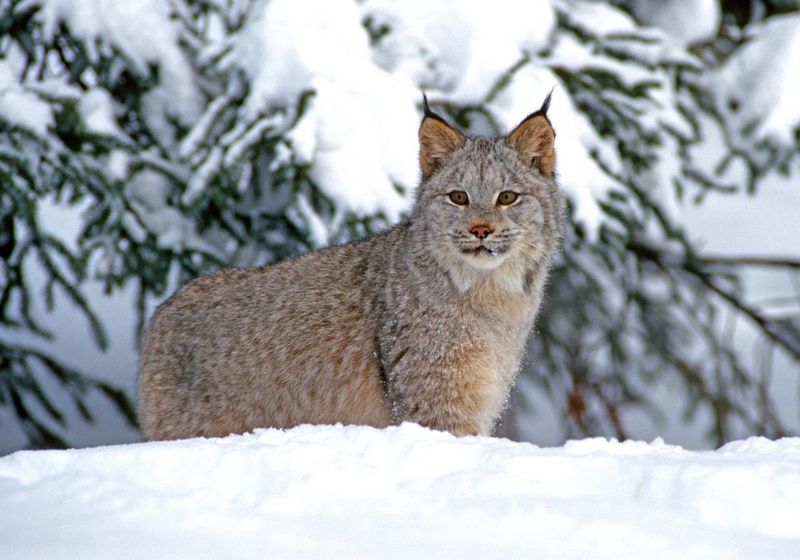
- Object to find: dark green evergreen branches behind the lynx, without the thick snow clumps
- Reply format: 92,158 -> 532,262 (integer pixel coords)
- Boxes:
0,0 -> 800,446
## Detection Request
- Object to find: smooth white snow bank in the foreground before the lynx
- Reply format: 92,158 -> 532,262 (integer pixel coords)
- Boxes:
0,424 -> 800,560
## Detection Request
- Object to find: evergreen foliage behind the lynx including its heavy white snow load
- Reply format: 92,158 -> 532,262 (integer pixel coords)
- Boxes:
0,0 -> 800,445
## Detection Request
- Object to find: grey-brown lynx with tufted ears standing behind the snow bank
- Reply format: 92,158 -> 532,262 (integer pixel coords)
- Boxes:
139,96 -> 562,439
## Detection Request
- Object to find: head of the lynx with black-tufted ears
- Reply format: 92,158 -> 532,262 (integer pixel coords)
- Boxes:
413,95 -> 562,292
